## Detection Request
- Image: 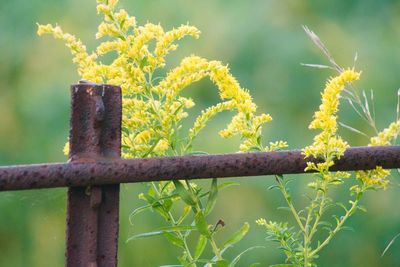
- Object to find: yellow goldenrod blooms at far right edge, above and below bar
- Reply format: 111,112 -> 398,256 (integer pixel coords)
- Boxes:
356,120 -> 400,188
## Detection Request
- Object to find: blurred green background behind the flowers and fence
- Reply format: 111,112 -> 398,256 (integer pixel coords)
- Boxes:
0,0 -> 400,267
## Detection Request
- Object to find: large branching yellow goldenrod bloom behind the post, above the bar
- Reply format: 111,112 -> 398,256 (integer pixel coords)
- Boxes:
38,0 -> 278,158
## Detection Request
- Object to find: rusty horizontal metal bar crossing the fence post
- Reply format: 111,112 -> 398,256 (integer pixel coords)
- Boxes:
0,146 -> 400,191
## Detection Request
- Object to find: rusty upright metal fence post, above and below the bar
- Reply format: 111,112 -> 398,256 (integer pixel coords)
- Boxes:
65,83 -> 121,267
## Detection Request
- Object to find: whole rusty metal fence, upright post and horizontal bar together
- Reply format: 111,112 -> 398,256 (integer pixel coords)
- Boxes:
0,84 -> 400,267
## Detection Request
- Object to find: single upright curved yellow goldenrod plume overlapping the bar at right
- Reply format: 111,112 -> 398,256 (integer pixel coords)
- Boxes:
303,69 -> 360,179
